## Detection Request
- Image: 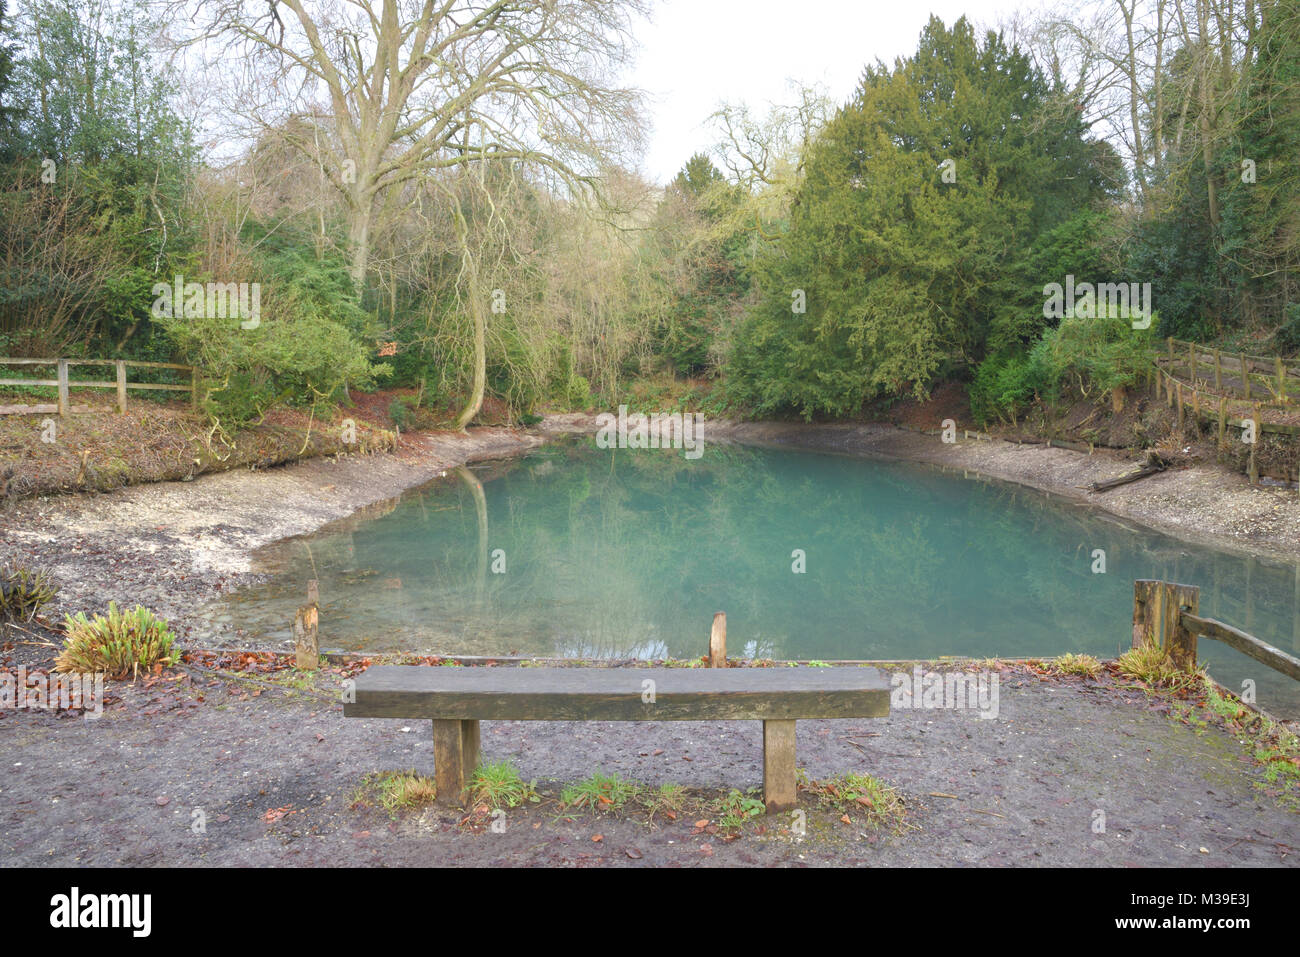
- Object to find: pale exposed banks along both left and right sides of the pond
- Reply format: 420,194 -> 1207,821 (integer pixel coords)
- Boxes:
0,413 -> 1300,637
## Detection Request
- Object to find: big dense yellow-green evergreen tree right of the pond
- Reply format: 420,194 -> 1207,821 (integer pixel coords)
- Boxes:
728,18 -> 1102,419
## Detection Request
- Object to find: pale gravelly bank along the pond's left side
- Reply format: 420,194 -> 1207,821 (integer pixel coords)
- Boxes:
0,428 -> 545,635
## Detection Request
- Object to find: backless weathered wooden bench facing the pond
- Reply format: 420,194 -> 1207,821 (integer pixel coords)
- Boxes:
343,664 -> 889,811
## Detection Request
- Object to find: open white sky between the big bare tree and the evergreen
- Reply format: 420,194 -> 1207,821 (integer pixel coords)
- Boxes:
629,0 -> 1041,183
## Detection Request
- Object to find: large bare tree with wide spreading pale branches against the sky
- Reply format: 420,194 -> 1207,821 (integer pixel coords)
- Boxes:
178,0 -> 645,287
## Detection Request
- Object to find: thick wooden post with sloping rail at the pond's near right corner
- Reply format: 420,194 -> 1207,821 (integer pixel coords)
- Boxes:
1134,579 -> 1300,681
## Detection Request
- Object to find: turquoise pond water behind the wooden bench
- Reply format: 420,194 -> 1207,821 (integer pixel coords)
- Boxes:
207,442 -> 1300,715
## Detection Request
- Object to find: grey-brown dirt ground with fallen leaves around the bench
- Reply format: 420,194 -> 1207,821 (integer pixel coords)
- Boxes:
0,657 -> 1300,867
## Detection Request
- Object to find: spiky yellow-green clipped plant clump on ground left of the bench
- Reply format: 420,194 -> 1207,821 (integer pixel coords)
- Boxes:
55,602 -> 179,677
